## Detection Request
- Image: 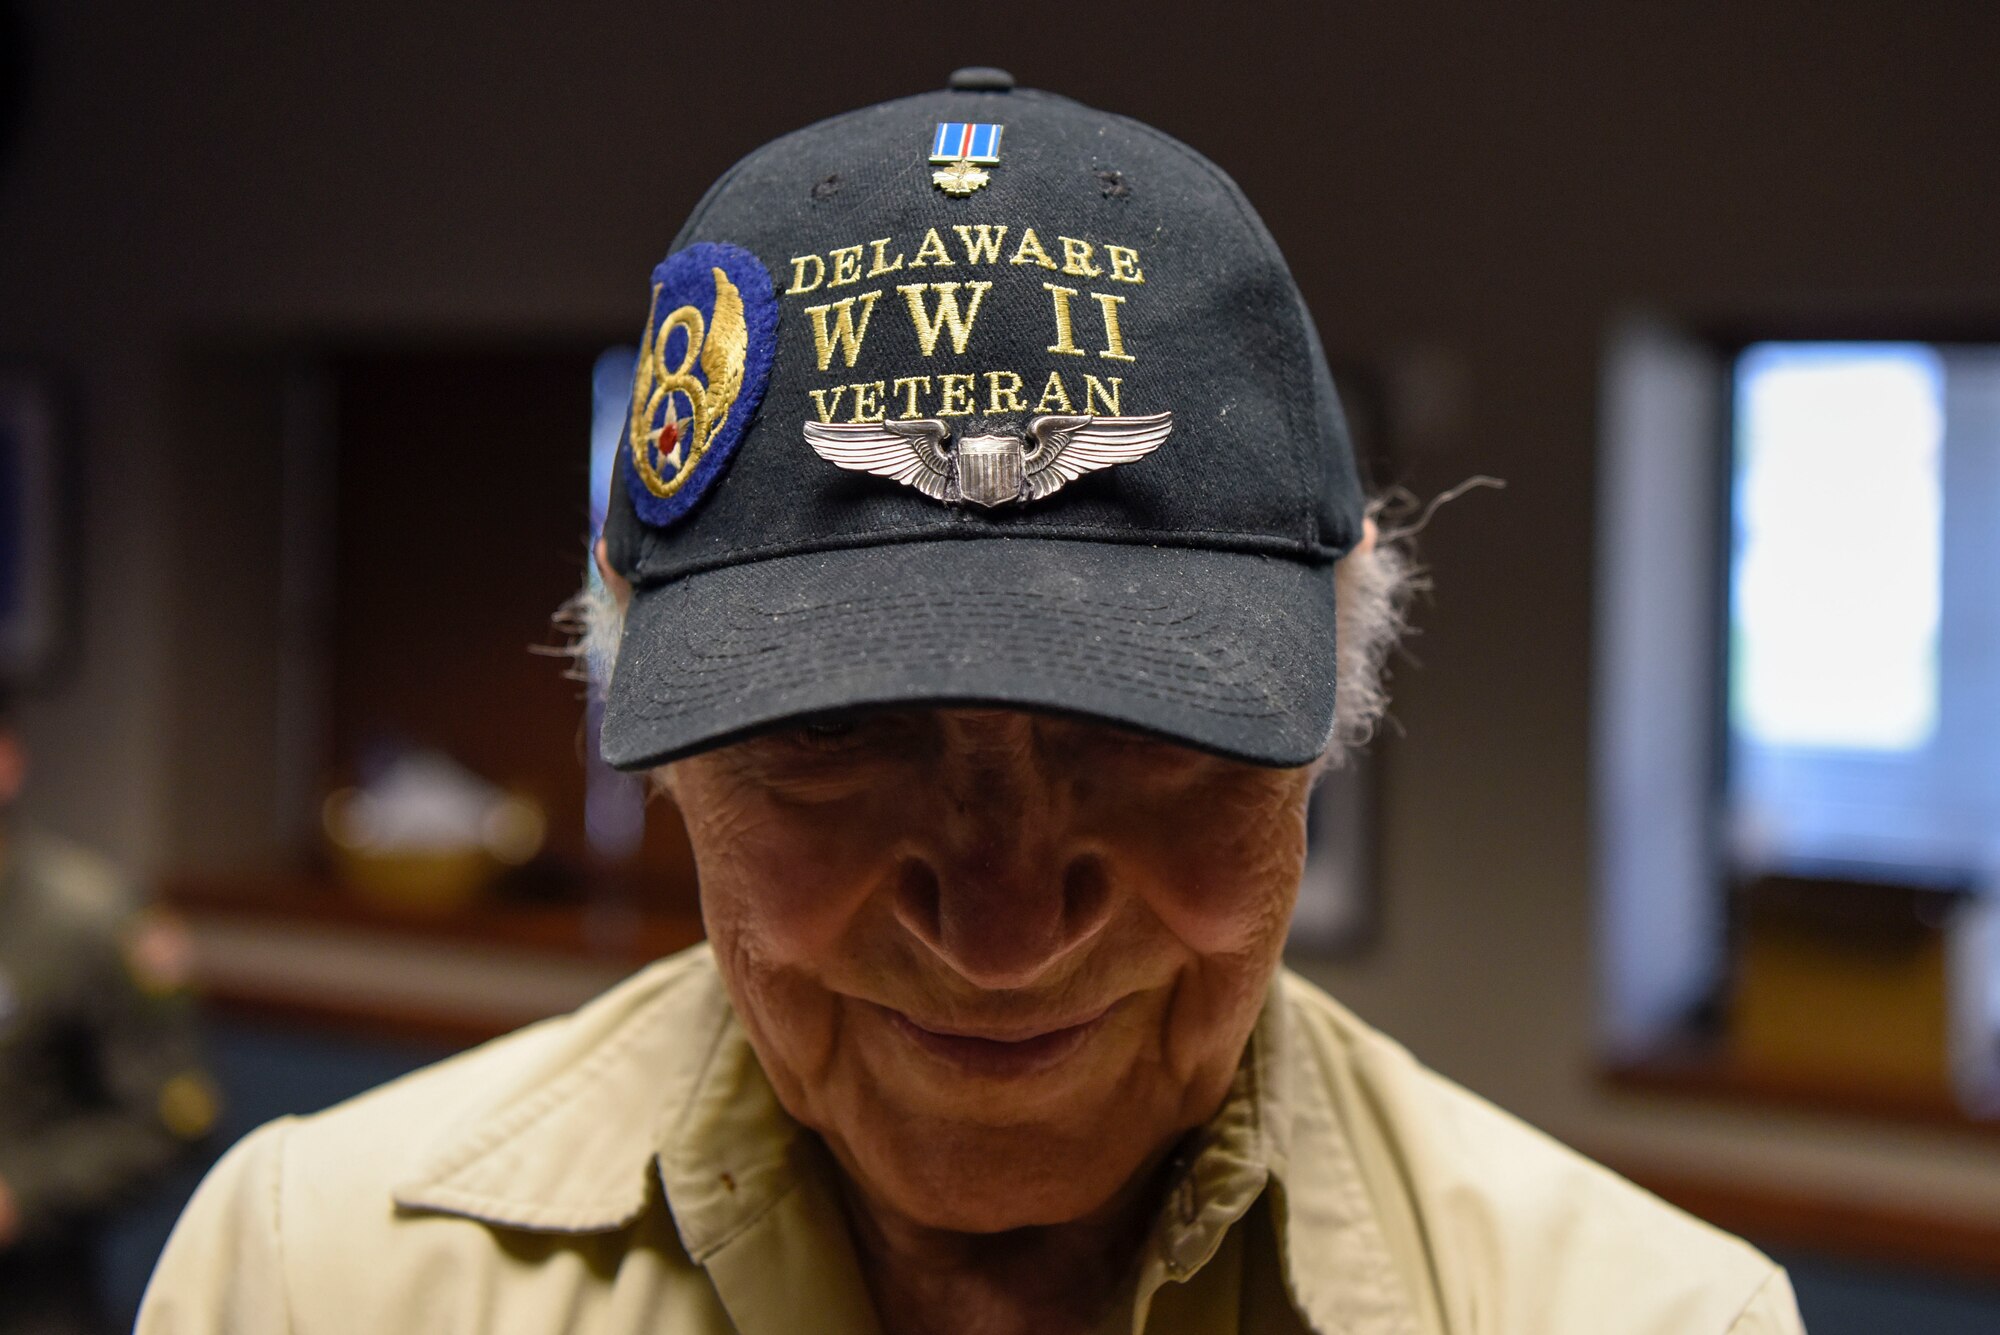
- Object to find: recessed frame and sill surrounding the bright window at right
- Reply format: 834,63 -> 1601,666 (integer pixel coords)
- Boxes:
1592,312 -> 2000,1131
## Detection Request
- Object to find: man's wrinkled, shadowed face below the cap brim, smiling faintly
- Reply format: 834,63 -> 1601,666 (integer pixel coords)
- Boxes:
668,709 -> 1310,1231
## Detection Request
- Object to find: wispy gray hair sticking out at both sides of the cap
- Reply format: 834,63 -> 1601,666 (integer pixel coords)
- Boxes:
556,523 -> 1428,769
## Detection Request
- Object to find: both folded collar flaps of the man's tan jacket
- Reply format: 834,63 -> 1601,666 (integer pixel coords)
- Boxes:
394,945 -> 1416,1335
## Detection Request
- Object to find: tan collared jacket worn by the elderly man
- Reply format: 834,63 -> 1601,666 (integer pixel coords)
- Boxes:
138,947 -> 1802,1335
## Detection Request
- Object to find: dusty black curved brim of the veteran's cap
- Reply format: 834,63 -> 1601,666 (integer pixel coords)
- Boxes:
602,538 -> 1334,769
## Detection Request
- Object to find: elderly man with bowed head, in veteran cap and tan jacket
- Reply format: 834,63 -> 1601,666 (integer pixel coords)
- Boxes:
140,70 -> 1800,1335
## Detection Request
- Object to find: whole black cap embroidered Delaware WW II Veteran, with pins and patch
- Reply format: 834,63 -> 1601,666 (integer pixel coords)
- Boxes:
602,70 -> 1362,769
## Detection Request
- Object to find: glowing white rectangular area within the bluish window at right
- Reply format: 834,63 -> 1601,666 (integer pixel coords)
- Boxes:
1730,344 -> 1944,751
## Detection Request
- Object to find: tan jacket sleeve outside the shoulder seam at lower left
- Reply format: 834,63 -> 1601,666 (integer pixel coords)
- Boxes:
134,1117 -> 292,1335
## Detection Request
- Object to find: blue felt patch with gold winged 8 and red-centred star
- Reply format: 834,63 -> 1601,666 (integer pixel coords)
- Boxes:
620,242 -> 778,528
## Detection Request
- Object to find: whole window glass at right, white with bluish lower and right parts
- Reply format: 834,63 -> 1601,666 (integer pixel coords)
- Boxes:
1726,344 -> 2000,881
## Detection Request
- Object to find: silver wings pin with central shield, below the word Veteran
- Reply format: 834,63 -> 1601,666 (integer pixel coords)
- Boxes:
806,412 -> 1174,508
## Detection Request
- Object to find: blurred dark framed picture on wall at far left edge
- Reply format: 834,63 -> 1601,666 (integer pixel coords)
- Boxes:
0,368 -> 62,681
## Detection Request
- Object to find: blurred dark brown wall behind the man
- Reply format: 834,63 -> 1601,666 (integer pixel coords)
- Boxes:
0,0 -> 2000,1327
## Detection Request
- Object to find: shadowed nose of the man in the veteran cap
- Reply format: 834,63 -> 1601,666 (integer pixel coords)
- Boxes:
896,713 -> 1112,989
